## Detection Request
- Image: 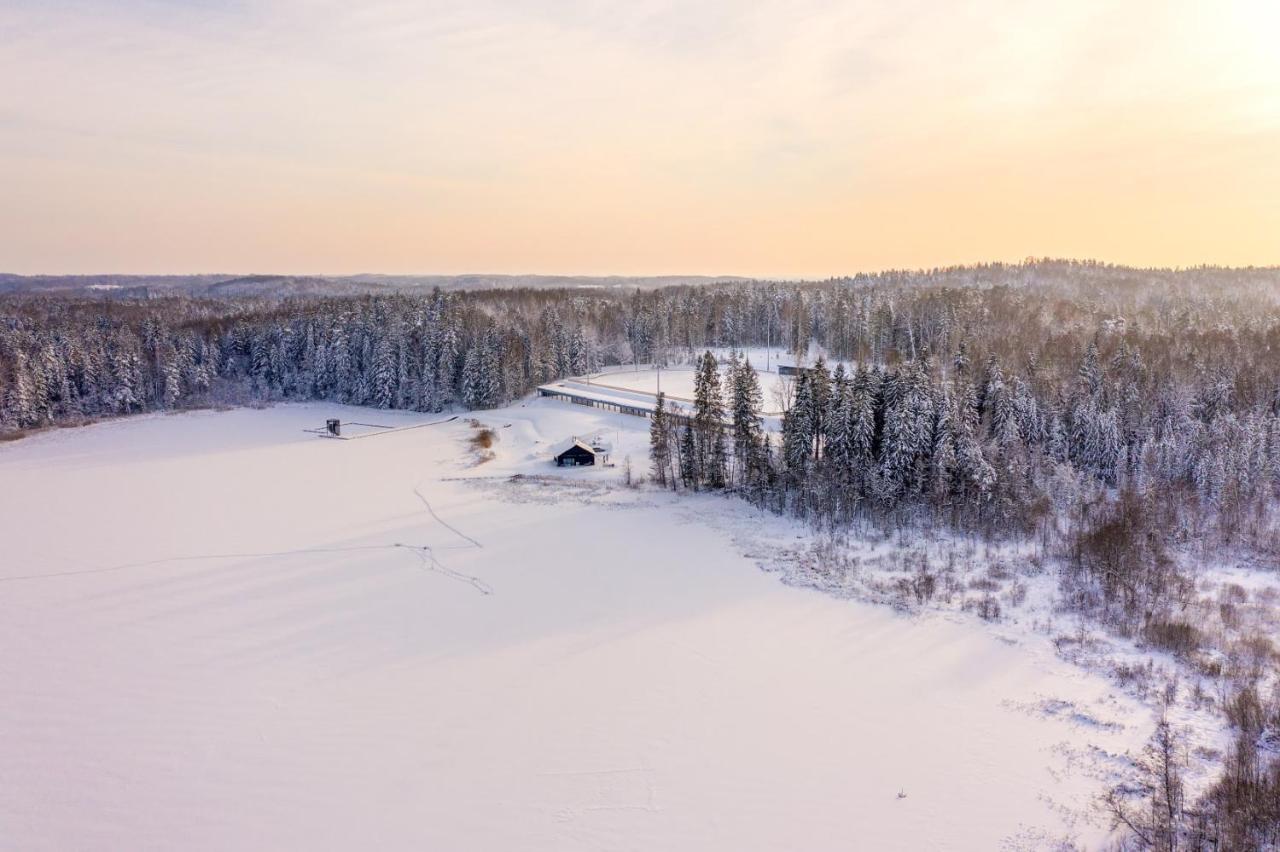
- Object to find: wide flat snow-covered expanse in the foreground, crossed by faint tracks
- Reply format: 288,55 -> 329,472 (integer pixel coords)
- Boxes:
0,399 -> 1152,851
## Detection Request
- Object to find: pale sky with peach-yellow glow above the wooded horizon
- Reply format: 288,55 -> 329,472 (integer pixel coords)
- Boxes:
0,0 -> 1280,276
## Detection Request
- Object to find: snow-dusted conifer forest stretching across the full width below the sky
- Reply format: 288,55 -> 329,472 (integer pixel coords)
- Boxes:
0,255 -> 1280,848
